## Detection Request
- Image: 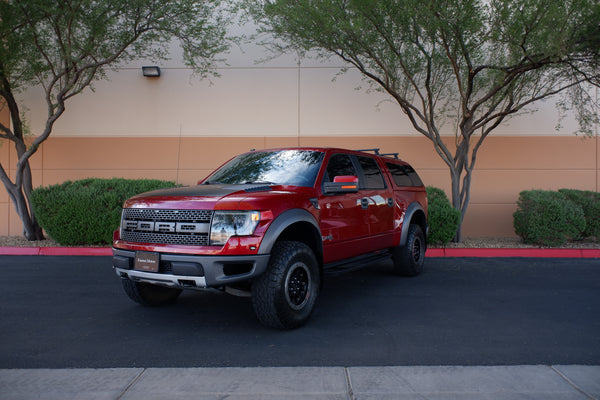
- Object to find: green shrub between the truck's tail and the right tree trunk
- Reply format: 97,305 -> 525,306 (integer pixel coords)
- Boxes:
427,186 -> 460,244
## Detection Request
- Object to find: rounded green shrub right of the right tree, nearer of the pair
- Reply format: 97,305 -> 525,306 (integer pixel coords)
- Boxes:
513,190 -> 585,246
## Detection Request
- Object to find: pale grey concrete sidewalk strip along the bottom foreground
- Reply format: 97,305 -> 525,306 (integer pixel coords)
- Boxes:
0,365 -> 600,400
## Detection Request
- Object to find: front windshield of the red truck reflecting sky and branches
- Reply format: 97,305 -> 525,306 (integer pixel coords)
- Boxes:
205,150 -> 323,187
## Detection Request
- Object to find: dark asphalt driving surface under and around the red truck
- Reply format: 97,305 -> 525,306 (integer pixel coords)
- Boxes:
0,256 -> 600,369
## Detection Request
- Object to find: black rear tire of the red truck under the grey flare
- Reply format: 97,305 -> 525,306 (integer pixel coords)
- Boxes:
392,224 -> 427,276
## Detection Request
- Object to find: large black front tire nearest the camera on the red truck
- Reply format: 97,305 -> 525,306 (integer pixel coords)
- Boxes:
252,241 -> 321,329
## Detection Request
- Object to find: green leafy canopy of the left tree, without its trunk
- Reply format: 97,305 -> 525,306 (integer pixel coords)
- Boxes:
0,0 -> 229,90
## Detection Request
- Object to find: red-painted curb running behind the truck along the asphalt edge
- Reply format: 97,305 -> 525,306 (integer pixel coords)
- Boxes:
0,247 -> 600,258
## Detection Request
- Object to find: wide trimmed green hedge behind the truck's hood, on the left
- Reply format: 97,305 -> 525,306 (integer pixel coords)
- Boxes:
31,178 -> 175,246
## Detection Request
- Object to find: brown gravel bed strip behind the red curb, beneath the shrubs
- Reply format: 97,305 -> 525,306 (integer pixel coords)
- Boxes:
0,236 -> 600,249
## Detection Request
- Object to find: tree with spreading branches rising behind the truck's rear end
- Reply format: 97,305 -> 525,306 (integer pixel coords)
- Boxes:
246,0 -> 600,240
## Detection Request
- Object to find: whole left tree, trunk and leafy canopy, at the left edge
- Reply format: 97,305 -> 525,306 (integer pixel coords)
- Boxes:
0,0 -> 230,240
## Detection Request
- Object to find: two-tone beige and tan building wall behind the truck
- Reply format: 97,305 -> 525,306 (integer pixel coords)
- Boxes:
0,37 -> 600,237
